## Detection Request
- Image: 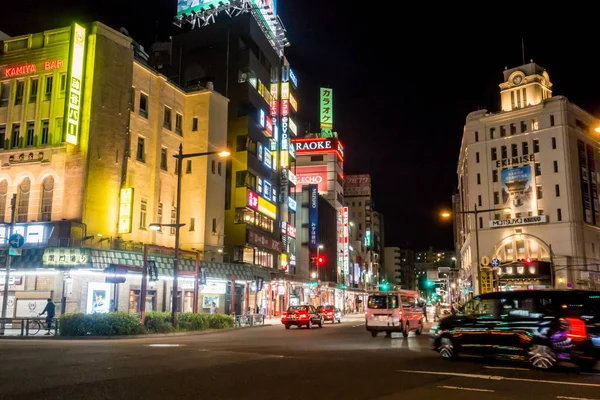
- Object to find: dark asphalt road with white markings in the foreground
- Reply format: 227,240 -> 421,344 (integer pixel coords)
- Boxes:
0,316 -> 600,400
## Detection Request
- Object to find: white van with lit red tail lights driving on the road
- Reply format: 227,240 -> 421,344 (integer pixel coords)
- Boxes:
365,290 -> 424,337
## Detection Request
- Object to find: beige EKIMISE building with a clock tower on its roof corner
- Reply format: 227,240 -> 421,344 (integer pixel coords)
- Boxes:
455,62 -> 600,294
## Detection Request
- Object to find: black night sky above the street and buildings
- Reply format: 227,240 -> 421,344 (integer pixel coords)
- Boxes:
0,0 -> 600,250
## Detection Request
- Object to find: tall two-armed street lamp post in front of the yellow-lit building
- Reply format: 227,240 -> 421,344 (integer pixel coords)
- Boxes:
149,144 -> 231,327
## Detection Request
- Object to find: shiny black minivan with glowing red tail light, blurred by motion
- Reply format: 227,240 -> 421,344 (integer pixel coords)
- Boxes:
432,289 -> 600,369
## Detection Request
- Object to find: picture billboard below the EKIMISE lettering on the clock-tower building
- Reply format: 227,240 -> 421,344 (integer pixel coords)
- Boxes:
502,165 -> 537,213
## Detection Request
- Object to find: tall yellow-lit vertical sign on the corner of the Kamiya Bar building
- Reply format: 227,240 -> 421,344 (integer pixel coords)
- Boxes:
64,24 -> 86,145
